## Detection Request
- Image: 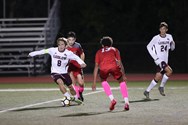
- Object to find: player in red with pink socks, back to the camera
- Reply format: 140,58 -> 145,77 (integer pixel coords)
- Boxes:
92,36 -> 129,111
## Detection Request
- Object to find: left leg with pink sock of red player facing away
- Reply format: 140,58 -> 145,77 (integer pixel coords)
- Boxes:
100,70 -> 116,111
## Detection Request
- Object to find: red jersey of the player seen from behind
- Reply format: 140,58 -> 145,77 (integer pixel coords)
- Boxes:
95,47 -> 121,70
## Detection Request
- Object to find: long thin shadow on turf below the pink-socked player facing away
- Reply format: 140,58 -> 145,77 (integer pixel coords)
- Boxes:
60,110 -> 126,117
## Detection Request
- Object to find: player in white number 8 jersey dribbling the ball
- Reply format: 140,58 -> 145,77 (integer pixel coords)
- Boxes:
29,38 -> 86,104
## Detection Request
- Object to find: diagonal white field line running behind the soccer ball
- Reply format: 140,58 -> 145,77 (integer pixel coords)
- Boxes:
0,88 -> 118,114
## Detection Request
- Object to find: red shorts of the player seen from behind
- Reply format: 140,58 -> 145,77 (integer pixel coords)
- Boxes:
100,67 -> 122,80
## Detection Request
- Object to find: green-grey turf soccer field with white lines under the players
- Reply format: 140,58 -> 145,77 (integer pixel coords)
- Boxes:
0,81 -> 188,125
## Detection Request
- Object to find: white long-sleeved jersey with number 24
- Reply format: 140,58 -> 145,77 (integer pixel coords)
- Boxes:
147,34 -> 175,63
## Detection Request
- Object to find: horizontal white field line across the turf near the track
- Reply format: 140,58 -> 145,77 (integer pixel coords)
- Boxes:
0,87 -> 188,92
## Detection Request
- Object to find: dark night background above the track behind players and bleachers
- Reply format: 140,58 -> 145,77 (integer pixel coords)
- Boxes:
0,0 -> 188,73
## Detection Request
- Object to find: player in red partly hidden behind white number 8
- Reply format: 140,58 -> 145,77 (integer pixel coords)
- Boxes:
67,31 -> 85,101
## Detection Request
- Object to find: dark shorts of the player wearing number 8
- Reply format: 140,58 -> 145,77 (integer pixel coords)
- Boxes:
51,73 -> 72,86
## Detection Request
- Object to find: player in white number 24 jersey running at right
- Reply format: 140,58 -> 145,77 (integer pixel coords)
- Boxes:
144,22 -> 175,99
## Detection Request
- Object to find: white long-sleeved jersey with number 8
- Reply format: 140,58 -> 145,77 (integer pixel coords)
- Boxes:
29,47 -> 85,74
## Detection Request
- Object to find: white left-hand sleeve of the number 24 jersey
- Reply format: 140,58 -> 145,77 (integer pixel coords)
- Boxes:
147,37 -> 158,60
